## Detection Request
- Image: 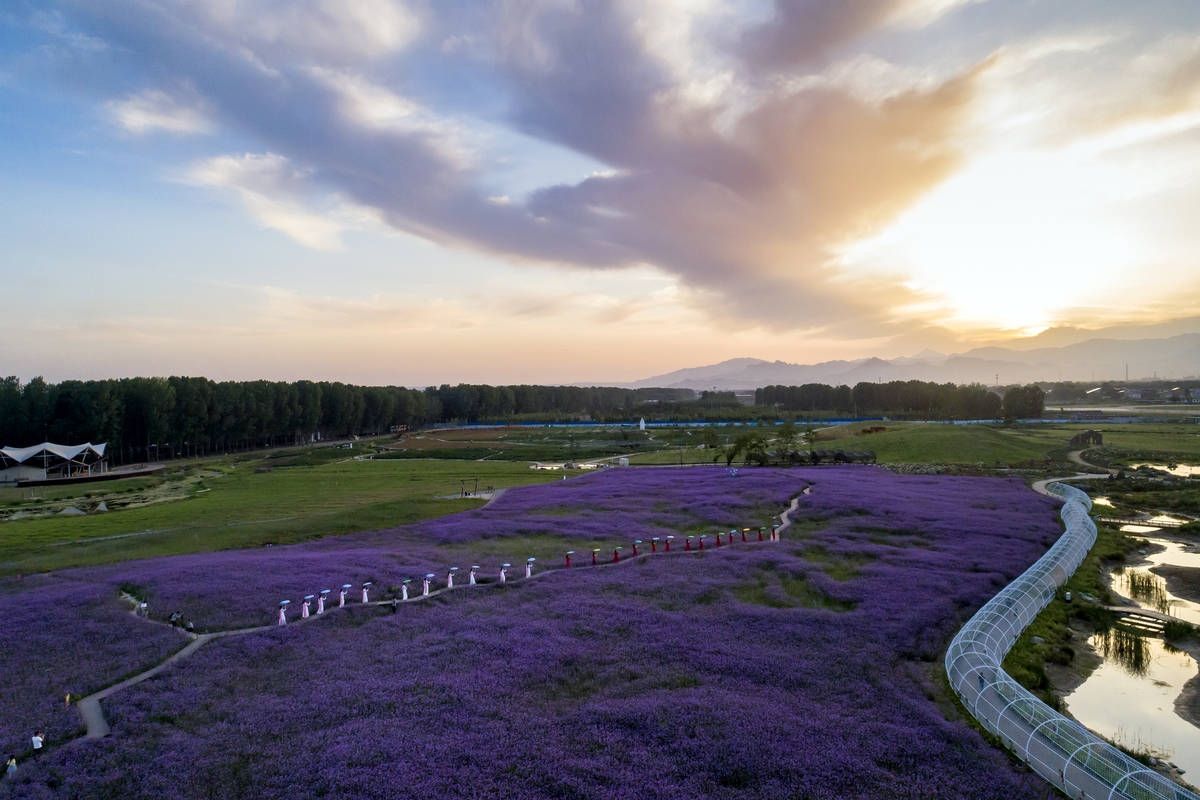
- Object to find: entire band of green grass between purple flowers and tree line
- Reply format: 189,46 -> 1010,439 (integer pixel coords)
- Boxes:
0,422 -> 1200,575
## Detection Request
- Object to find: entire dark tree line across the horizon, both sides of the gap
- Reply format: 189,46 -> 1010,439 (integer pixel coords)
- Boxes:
0,377 -> 1044,464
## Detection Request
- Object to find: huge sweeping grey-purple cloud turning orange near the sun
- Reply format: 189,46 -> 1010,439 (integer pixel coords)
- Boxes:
35,0 -> 1200,352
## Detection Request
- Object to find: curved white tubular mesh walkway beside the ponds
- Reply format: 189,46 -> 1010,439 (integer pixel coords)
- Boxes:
946,483 -> 1200,800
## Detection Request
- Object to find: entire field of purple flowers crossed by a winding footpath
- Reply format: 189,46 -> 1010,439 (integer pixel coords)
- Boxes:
0,468 -> 1058,798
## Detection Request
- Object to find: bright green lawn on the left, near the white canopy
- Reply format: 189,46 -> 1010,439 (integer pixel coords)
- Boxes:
0,459 -> 580,575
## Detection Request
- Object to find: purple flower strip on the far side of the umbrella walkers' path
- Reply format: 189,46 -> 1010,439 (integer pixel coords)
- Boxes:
54,469 -> 806,631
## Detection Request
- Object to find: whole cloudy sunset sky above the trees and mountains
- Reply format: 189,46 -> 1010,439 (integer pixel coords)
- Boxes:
0,0 -> 1200,386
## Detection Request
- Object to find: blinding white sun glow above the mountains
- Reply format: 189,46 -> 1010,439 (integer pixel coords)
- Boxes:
842,152 -> 1139,332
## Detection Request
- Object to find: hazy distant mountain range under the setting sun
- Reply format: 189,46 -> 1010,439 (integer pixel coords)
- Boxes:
626,329 -> 1200,391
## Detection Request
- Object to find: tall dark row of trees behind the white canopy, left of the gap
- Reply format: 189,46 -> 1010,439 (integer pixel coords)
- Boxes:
0,377 -> 692,464
